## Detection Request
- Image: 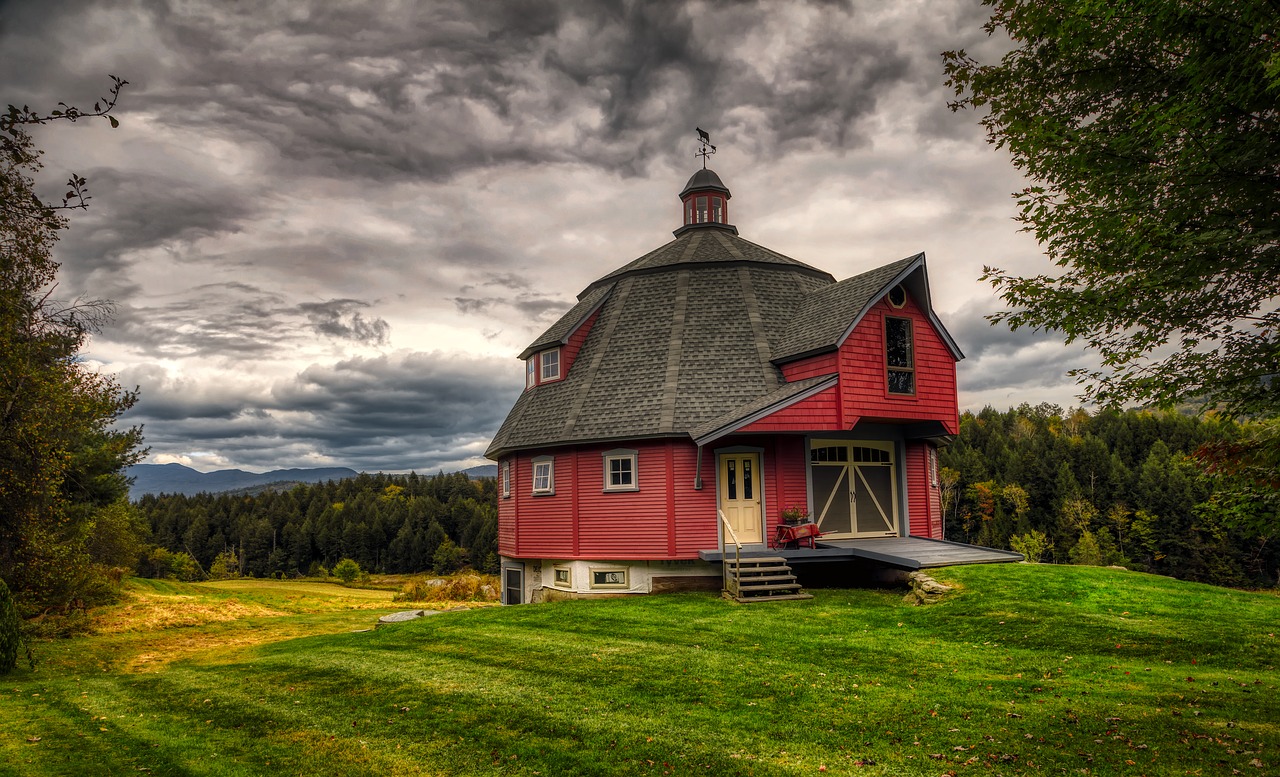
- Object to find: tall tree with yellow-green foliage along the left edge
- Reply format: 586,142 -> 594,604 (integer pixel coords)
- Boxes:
0,77 -> 142,614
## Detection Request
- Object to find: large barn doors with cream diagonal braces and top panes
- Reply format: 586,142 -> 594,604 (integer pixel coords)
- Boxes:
809,440 -> 897,539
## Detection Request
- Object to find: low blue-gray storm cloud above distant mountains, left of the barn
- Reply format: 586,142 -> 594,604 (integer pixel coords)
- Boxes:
122,353 -> 520,471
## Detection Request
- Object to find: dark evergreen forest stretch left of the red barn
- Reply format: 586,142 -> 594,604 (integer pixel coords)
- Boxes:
136,472 -> 498,577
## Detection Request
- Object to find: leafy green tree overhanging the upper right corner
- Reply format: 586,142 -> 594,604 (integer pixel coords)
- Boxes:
943,0 -> 1280,416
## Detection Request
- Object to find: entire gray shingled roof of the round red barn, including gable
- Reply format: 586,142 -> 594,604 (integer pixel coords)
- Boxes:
485,179 -> 959,458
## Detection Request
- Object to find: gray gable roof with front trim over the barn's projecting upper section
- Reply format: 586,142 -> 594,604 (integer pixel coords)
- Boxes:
773,253 -> 964,364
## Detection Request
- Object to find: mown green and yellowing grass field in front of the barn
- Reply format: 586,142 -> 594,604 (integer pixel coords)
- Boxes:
0,565 -> 1280,776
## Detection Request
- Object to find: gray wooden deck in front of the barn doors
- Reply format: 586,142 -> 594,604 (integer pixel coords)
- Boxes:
698,536 -> 1023,570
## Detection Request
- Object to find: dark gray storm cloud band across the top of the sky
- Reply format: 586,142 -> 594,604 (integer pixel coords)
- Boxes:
0,0 -> 980,179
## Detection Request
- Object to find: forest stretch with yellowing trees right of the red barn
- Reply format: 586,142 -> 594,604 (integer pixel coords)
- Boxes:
938,405 -> 1280,586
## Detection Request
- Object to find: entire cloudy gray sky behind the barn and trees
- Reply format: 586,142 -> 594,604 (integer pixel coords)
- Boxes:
0,0 -> 1087,471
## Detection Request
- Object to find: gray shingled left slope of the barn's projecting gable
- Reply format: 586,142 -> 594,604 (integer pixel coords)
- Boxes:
773,253 -> 924,362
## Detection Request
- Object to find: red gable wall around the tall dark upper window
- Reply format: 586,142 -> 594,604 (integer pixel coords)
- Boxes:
840,297 -> 960,434
